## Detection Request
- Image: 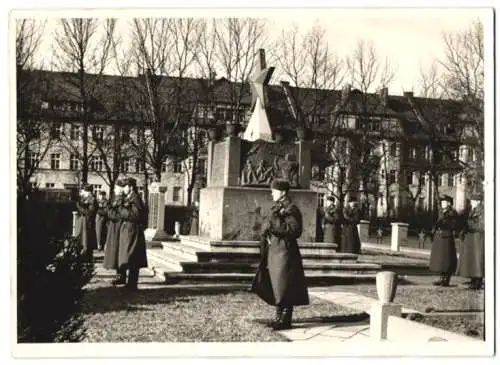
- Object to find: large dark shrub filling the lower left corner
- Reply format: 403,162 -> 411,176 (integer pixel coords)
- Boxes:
17,196 -> 94,342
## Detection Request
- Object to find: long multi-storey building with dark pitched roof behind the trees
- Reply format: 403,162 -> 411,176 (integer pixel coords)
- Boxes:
18,66 -> 479,216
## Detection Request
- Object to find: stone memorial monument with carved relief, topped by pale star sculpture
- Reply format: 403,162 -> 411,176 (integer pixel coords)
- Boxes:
199,50 -> 316,242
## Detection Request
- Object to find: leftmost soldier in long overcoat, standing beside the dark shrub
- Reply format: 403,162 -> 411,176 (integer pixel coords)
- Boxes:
76,185 -> 97,261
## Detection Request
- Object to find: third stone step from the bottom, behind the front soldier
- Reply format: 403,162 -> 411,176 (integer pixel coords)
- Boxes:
196,251 -> 357,264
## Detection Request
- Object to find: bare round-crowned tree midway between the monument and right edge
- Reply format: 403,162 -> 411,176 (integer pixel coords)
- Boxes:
327,41 -> 400,214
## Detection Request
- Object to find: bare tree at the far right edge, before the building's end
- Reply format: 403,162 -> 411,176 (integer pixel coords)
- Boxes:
411,21 -> 484,211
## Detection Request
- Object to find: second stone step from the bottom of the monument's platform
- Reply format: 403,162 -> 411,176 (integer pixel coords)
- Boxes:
180,262 -> 380,274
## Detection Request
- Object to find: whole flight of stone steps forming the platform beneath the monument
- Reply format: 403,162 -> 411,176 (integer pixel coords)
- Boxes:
148,236 -> 380,285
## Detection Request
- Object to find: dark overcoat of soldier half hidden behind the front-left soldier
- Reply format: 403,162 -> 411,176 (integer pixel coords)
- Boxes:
103,196 -> 123,269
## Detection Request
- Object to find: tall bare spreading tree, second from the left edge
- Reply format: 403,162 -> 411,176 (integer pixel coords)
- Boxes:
54,18 -> 116,184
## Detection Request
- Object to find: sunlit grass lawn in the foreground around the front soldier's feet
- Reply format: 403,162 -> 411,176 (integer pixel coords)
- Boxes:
84,273 -> 362,342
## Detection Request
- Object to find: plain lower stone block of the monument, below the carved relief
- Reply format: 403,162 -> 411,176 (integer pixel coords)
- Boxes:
199,186 -> 317,242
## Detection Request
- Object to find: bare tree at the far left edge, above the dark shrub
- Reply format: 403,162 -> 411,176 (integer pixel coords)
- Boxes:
16,19 -> 53,198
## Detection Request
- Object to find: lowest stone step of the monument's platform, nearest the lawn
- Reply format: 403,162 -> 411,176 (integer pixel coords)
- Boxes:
164,272 -> 376,289
